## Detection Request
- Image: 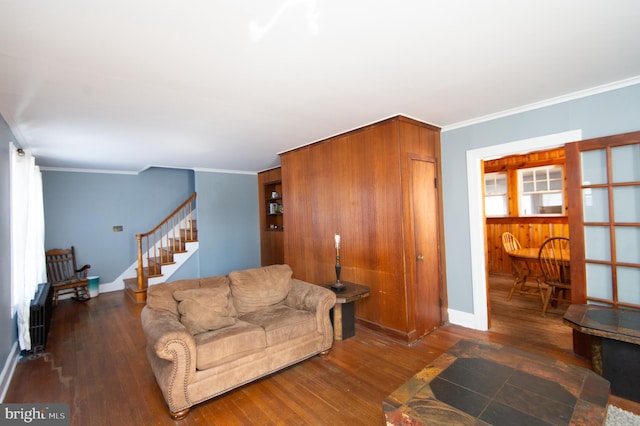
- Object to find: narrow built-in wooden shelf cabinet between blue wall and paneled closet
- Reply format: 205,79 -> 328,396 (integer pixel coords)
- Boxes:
258,167 -> 284,266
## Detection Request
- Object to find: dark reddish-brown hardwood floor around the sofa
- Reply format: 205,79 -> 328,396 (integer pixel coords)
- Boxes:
4,277 -> 640,426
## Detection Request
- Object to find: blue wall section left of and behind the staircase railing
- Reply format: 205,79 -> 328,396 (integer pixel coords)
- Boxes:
42,166 -> 195,283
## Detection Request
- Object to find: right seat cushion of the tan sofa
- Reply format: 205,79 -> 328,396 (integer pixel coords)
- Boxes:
240,305 -> 317,346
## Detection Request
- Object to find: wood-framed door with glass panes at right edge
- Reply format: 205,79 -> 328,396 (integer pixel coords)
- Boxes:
567,132 -> 640,308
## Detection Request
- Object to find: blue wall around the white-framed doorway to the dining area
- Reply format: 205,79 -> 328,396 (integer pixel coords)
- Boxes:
441,84 -> 640,313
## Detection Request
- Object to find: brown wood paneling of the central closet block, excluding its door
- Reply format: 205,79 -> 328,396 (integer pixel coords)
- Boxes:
281,117 -> 440,342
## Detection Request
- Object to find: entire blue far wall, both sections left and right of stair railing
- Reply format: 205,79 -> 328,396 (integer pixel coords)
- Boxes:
43,168 -> 260,284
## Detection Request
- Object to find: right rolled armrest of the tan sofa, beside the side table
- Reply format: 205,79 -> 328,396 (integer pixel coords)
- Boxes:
285,278 -> 336,350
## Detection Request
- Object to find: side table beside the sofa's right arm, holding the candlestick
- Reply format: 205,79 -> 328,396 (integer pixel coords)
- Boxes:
322,281 -> 371,340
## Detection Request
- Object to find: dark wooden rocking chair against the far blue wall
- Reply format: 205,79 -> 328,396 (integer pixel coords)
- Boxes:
45,246 -> 91,305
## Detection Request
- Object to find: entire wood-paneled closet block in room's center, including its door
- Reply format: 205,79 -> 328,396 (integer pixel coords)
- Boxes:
281,116 -> 447,341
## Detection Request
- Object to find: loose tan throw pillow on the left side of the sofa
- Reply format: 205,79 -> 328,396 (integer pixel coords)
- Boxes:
173,285 -> 236,335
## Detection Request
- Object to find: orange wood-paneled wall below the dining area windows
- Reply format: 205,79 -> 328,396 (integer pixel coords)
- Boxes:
485,217 -> 569,274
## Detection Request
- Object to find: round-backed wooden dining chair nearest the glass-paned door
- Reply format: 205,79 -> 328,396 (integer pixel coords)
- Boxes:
538,237 -> 571,317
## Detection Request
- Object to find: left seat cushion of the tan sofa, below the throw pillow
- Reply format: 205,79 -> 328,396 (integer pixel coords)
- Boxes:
194,321 -> 266,370
